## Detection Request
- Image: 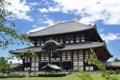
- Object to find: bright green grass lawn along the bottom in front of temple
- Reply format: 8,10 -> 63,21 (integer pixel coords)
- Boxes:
0,74 -> 120,80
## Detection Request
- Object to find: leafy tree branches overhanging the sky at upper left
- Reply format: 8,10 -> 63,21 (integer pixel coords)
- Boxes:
0,0 -> 29,48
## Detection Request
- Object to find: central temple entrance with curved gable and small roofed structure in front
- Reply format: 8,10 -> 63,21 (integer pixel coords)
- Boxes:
41,40 -> 63,72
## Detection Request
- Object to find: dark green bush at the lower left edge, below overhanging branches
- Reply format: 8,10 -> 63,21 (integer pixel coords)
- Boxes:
0,57 -> 12,74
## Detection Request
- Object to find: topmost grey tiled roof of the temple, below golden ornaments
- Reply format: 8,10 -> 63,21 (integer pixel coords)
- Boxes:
27,21 -> 94,37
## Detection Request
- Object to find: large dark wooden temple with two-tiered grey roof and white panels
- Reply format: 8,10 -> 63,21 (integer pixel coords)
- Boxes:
10,21 -> 112,71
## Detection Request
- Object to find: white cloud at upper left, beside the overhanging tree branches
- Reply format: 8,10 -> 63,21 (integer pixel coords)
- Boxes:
5,0 -> 33,21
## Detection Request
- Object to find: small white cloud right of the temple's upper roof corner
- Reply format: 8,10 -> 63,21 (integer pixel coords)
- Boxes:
100,33 -> 120,42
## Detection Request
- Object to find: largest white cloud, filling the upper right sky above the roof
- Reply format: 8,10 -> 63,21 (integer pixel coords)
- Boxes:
38,0 -> 120,25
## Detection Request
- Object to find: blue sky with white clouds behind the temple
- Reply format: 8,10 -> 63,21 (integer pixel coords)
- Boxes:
0,0 -> 120,62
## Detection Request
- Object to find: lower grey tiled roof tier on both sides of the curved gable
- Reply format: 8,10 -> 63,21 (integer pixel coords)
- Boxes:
10,42 -> 105,53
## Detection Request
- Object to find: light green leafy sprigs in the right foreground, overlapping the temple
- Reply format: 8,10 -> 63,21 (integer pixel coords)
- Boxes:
78,48 -> 118,80
